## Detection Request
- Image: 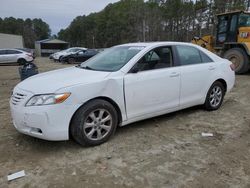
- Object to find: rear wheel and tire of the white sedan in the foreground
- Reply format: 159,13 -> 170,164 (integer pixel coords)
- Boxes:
204,81 -> 226,111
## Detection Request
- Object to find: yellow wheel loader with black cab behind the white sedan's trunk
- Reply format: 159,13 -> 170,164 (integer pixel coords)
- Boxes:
192,11 -> 250,74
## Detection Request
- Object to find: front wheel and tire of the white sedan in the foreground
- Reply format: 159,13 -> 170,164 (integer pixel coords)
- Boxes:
70,99 -> 118,146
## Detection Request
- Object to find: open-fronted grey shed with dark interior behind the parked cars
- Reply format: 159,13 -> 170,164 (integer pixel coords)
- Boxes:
35,39 -> 69,56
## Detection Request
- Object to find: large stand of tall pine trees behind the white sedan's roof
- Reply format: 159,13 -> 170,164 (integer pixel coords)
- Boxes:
58,0 -> 249,48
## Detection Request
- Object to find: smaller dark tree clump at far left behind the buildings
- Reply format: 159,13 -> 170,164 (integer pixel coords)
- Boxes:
0,17 -> 51,48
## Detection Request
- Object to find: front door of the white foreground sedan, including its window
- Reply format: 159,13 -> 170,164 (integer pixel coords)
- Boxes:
124,46 -> 180,119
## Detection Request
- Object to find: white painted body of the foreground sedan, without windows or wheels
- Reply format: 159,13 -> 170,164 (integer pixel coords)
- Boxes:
10,42 -> 235,140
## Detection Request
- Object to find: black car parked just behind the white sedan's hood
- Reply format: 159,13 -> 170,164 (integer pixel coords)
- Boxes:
61,49 -> 98,64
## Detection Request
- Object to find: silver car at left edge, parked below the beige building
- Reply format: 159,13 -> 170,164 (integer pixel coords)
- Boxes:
0,49 -> 34,65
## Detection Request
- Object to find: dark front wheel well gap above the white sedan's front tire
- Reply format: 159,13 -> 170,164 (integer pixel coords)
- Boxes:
69,96 -> 122,137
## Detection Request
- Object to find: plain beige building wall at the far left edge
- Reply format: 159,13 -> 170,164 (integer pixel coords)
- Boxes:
0,33 -> 23,49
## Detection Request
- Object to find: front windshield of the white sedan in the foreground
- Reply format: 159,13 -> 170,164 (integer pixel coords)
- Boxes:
80,46 -> 144,72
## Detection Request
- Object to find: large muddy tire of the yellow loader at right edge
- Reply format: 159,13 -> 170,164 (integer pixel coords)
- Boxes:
223,48 -> 249,74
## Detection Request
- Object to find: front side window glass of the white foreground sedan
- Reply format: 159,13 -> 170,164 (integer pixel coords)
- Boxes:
131,47 -> 173,72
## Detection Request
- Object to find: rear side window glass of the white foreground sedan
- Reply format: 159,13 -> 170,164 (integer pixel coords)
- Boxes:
176,46 -> 213,65
